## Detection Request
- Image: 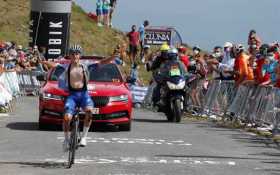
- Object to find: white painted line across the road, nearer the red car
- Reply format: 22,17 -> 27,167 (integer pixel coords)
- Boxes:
57,135 -> 192,146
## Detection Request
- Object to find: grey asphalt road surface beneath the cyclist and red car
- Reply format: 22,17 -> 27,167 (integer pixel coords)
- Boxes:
0,97 -> 280,175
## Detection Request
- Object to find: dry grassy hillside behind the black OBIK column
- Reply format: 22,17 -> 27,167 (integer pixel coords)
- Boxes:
0,0 -> 125,55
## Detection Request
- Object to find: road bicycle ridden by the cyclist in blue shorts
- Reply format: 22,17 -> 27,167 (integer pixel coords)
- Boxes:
67,109 -> 81,168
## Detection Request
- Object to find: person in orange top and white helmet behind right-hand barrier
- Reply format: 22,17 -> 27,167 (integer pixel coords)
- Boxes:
233,44 -> 249,86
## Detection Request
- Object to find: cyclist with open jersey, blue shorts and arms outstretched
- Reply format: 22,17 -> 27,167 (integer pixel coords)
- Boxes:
59,45 -> 115,152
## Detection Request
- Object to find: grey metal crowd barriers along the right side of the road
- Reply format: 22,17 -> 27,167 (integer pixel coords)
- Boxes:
200,80 -> 280,128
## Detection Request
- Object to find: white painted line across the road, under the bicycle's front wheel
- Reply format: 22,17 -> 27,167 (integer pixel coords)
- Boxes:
44,156 -> 236,166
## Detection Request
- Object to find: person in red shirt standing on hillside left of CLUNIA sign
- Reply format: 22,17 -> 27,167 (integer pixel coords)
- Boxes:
127,25 -> 139,64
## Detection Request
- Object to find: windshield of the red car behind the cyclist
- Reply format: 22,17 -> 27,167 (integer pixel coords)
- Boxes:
50,64 -> 122,82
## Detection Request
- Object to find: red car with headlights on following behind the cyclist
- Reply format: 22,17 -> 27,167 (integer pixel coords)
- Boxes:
39,57 -> 132,131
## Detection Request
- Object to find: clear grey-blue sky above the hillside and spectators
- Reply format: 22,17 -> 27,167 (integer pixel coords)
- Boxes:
75,0 -> 280,50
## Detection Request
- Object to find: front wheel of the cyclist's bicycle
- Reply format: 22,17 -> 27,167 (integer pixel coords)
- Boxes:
68,119 -> 79,168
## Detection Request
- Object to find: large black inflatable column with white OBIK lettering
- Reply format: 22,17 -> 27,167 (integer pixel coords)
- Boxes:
29,0 -> 72,59
